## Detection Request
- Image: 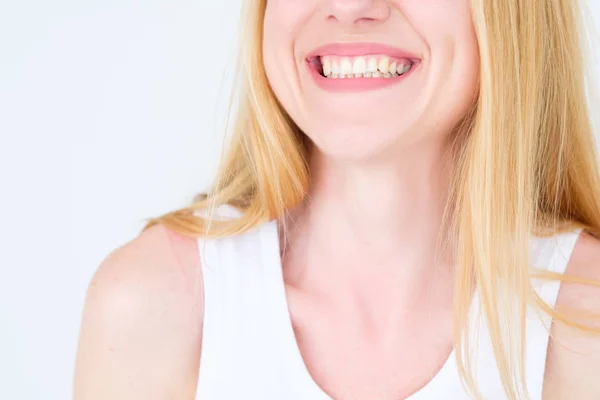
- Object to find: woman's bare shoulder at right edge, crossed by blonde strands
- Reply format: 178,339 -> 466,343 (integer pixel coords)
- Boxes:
544,232 -> 600,399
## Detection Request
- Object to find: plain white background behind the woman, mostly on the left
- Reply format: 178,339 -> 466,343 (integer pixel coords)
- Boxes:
0,0 -> 600,400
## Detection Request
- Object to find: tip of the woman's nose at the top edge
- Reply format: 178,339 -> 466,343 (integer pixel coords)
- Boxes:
329,0 -> 390,24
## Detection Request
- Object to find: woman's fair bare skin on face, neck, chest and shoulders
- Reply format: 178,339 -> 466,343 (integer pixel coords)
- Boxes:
75,0 -> 600,400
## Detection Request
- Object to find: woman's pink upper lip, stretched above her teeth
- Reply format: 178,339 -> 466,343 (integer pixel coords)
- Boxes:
306,42 -> 419,61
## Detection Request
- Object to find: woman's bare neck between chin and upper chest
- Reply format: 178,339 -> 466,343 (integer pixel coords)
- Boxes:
287,138 -> 450,276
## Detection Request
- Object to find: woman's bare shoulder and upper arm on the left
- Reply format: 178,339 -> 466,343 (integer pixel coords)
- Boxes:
74,225 -> 203,399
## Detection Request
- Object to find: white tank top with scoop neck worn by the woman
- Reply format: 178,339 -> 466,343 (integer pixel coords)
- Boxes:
196,209 -> 581,400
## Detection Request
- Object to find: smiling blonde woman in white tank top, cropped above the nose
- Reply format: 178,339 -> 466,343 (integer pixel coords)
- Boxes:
75,0 -> 600,400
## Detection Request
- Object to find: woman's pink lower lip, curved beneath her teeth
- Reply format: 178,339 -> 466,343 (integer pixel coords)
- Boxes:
307,63 -> 419,92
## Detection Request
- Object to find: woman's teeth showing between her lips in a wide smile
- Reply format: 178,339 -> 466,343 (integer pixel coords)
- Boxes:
321,55 -> 413,78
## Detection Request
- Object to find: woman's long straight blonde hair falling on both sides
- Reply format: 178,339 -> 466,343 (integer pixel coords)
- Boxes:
144,0 -> 600,399
